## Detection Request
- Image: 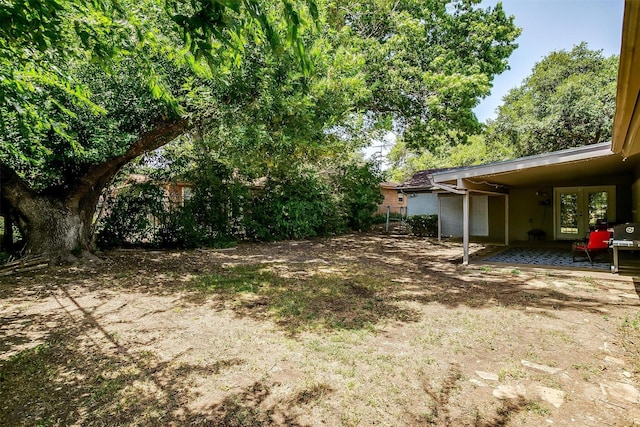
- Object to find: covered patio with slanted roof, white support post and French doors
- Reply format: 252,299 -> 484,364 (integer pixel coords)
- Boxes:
433,142 -> 638,269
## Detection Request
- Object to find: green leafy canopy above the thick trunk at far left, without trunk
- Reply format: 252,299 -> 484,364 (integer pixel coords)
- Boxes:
0,0 -> 317,191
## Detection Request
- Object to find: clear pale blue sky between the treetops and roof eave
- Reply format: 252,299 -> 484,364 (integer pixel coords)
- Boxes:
474,0 -> 624,122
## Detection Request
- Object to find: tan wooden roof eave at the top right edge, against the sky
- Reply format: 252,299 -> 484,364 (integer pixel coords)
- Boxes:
611,0 -> 640,158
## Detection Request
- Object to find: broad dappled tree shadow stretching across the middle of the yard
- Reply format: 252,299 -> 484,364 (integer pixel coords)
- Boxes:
0,236 -> 636,345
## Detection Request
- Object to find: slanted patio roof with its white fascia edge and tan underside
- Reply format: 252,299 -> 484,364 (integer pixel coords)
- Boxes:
433,142 -> 637,192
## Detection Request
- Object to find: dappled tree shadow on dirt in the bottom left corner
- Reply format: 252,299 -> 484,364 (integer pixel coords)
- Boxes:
0,311 -> 332,427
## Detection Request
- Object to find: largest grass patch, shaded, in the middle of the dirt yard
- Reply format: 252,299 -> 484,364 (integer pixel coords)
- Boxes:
193,264 -> 414,333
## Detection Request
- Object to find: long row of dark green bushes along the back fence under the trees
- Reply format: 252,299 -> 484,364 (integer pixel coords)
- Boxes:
96,166 -> 382,248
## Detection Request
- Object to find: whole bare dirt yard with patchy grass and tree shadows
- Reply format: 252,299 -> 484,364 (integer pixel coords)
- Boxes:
0,235 -> 640,427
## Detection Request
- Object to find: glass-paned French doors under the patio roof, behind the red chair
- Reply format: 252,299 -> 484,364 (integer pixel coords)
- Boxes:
553,185 -> 616,240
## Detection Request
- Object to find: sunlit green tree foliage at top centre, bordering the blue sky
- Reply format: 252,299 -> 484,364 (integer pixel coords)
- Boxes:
340,0 -> 520,148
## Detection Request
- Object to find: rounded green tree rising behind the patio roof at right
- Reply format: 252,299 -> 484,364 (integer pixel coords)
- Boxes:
486,42 -> 618,156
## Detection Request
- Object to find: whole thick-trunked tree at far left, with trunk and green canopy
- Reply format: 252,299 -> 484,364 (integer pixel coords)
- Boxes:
0,0 -> 315,258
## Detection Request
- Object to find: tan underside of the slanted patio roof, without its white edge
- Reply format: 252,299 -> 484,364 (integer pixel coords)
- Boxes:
437,146 -> 640,188
